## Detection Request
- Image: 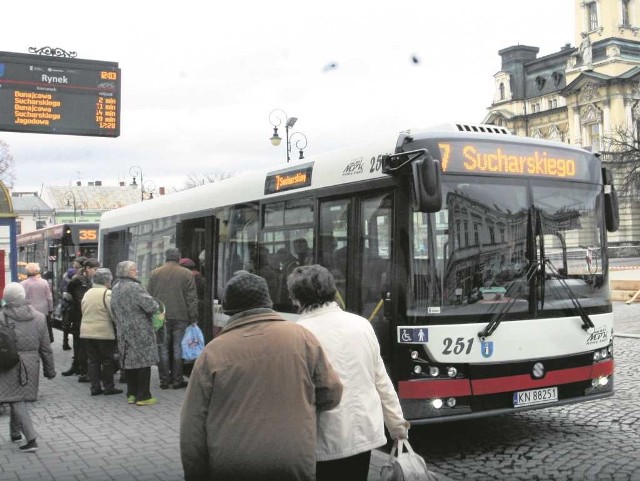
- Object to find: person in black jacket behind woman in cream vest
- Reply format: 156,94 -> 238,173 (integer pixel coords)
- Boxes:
62,257 -> 100,382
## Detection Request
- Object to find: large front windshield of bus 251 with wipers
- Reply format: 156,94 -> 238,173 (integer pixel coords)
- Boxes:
407,176 -> 609,323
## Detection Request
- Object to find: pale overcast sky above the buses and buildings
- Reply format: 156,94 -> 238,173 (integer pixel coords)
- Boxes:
0,0 -> 575,190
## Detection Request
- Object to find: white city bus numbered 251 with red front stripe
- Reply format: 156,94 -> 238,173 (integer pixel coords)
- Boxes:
99,124 -> 619,424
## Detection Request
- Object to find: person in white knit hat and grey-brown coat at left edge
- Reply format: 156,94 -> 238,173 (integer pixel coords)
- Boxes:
0,282 -> 56,453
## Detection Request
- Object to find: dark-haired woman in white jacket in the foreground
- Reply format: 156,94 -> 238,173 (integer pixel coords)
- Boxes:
287,265 -> 410,481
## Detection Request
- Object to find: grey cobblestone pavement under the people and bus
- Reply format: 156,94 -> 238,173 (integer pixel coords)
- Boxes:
0,303 -> 640,481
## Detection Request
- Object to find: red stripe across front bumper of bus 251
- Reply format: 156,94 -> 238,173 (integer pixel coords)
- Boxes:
398,359 -> 614,399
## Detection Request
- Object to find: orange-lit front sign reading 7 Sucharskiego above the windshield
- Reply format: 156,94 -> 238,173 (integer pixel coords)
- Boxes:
438,141 -> 591,180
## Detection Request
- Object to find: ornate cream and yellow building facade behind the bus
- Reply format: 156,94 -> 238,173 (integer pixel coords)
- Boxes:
484,0 -> 640,255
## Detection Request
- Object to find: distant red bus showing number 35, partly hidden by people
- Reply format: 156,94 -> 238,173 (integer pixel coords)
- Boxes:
16,222 -> 99,303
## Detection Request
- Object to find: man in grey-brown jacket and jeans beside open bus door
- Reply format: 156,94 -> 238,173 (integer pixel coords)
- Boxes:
148,247 -> 198,389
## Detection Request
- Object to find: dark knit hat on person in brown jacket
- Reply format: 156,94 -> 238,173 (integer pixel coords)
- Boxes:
222,271 -> 273,315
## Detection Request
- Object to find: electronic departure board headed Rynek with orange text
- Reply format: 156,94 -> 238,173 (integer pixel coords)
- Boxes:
0,52 -> 120,137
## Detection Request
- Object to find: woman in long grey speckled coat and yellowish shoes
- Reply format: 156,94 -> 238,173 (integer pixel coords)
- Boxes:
111,261 -> 159,406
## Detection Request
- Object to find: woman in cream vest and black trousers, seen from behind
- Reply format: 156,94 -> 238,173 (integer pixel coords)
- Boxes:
80,267 -> 122,396
